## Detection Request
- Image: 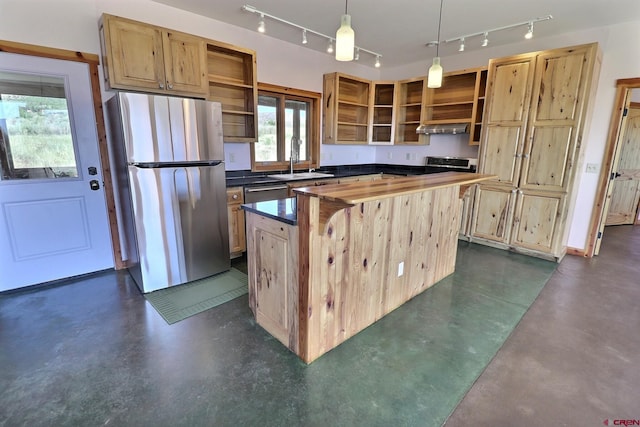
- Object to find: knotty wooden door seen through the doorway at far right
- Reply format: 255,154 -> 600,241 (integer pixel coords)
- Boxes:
605,104 -> 640,225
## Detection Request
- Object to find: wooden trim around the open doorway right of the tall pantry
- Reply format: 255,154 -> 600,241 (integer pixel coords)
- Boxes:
584,77 -> 640,257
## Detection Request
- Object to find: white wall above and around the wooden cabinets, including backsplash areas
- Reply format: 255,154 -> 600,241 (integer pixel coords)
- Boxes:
5,0 -> 640,248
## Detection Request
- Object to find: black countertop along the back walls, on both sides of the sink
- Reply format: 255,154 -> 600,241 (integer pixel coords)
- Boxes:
226,163 -> 429,187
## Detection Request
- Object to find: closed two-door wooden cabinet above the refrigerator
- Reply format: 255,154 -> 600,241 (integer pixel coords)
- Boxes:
100,14 -> 208,98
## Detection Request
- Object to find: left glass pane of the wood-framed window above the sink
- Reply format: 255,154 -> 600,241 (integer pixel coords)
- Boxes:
254,95 -> 280,162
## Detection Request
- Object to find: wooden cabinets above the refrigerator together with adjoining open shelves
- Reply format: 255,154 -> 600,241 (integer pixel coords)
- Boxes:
100,14 -> 258,142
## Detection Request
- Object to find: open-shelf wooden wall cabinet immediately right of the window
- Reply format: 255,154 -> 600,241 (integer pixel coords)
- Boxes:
323,73 -> 371,144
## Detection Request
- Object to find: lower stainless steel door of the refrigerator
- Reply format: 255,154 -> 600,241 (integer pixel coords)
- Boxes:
129,164 -> 230,292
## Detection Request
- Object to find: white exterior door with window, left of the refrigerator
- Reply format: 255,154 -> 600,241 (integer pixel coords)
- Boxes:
0,53 -> 113,291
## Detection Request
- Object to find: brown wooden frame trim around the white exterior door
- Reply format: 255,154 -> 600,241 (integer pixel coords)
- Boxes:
0,40 -> 126,270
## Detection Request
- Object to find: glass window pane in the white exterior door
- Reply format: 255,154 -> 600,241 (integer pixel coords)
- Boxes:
0,72 -> 78,180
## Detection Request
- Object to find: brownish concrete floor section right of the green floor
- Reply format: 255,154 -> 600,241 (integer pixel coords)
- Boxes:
446,226 -> 640,427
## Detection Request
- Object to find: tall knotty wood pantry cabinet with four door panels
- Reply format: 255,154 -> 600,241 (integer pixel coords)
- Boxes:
471,43 -> 600,261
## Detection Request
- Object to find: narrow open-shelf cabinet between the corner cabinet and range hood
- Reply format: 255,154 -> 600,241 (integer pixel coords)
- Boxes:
395,77 -> 429,145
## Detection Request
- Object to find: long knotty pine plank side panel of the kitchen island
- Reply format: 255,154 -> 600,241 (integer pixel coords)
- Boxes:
298,185 -> 460,363
